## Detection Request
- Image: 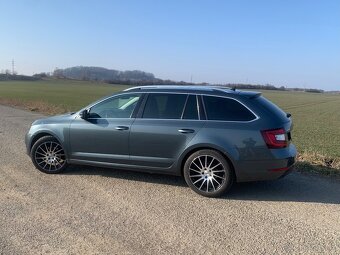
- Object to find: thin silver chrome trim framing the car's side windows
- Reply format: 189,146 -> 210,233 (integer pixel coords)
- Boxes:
77,91 -> 260,123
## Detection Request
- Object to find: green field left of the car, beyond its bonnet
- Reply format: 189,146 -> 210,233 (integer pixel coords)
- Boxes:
0,80 -> 129,112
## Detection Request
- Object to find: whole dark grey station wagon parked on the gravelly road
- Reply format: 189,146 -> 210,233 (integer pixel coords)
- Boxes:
26,86 -> 296,197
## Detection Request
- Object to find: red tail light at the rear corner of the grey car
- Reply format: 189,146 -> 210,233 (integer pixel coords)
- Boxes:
261,128 -> 288,149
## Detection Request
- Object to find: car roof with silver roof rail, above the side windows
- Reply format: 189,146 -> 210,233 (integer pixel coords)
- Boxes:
124,85 -> 261,98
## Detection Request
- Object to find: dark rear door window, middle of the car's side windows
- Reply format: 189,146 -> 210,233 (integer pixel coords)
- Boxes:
143,93 -> 187,119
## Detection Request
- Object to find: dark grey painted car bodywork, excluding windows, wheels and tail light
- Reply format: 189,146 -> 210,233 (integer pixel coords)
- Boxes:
26,86 -> 296,182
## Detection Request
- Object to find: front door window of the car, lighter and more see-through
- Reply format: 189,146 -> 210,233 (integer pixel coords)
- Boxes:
89,94 -> 140,118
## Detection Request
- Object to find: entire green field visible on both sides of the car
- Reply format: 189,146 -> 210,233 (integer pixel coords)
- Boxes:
0,80 -> 340,171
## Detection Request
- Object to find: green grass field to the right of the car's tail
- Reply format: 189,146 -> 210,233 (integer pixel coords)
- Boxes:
263,91 -> 340,158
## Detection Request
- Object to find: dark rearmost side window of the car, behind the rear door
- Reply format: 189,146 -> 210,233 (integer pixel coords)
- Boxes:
203,96 -> 256,121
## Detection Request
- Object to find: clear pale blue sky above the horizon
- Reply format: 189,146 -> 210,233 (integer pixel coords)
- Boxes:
0,0 -> 340,90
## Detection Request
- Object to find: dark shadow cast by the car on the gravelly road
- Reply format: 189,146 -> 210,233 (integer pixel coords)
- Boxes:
63,166 -> 340,204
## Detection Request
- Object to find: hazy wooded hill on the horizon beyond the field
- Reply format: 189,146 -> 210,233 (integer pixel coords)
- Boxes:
53,66 -> 155,82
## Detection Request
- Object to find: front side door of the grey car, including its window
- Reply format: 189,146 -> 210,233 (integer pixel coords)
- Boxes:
70,93 -> 141,164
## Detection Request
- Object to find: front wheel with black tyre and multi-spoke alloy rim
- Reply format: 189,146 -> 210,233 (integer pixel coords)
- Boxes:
31,136 -> 67,174
